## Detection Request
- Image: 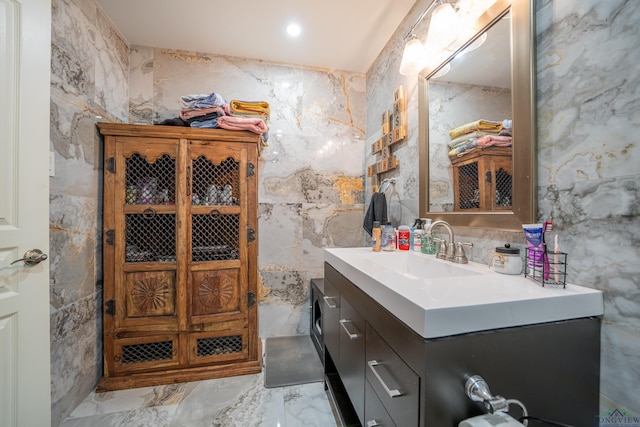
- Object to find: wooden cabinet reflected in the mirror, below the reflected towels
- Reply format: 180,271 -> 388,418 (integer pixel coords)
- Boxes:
451,147 -> 513,212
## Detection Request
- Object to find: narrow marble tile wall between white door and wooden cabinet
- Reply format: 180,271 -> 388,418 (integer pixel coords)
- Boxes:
49,0 -> 129,425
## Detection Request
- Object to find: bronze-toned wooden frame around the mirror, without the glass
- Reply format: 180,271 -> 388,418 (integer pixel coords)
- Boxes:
418,0 -> 537,231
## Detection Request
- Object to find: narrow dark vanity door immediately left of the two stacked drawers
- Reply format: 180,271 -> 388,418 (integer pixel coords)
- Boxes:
336,298 -> 365,423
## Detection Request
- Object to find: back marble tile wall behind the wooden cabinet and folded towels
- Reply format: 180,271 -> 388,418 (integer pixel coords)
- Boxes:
129,46 -> 365,338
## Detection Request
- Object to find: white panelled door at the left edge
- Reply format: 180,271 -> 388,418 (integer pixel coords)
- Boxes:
0,0 -> 51,427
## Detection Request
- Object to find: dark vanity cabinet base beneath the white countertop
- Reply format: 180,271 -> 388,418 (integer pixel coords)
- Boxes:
323,263 -> 600,427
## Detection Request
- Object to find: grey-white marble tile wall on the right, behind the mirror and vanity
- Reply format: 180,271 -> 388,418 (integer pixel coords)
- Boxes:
365,0 -> 640,415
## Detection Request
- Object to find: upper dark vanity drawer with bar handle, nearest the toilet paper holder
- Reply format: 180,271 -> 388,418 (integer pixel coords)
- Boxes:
366,323 -> 420,427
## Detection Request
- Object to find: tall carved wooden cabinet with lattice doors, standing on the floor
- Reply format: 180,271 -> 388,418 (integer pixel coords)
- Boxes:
98,123 -> 261,391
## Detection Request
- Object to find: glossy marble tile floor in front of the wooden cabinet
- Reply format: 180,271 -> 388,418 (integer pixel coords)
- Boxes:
60,373 -> 337,427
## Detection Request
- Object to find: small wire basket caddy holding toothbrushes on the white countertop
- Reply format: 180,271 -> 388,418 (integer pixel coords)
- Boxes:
524,248 -> 567,288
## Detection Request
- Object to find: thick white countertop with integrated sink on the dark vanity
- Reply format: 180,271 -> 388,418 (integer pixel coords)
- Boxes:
324,248 -> 603,338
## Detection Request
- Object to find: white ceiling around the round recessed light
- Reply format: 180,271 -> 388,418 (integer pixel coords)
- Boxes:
97,0 -> 416,73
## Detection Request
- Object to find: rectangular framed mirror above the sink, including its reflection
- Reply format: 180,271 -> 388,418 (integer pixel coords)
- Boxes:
419,0 -> 536,230
